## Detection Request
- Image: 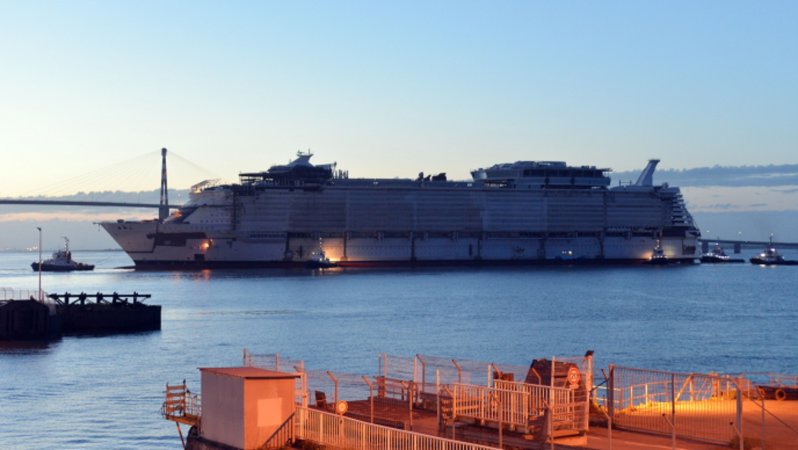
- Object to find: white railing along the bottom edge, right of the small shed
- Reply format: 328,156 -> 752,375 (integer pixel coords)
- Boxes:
295,406 -> 497,450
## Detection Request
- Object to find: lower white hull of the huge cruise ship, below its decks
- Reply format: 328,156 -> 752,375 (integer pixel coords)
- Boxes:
105,224 -> 695,268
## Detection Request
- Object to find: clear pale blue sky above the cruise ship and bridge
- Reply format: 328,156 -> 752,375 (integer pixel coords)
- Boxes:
0,0 -> 798,196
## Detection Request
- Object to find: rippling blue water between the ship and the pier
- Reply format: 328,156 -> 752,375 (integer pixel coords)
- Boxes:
0,252 -> 798,449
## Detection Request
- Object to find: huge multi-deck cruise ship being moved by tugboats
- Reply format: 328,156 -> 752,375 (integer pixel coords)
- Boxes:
101,152 -> 700,269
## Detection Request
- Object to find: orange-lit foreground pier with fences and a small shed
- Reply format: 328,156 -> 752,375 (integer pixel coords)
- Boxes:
162,350 -> 798,450
